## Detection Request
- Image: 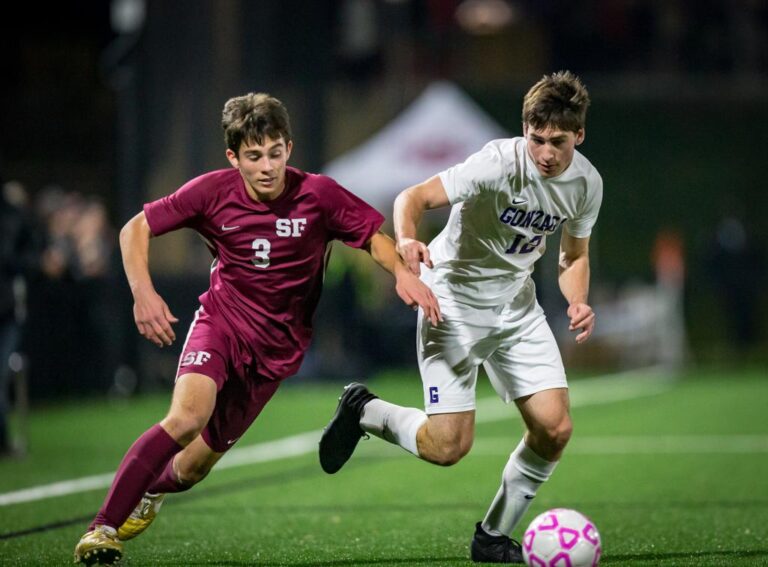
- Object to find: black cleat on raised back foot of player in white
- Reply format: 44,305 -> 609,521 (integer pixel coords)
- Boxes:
320,382 -> 378,474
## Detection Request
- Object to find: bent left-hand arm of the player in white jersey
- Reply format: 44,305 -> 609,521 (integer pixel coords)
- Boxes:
394,175 -> 450,276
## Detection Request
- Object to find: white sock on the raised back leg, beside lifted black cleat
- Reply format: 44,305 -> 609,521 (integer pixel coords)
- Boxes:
360,398 -> 429,457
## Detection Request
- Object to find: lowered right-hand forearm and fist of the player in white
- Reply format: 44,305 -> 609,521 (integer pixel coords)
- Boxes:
558,228 -> 595,343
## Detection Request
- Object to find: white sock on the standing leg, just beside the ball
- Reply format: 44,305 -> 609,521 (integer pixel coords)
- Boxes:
482,440 -> 557,536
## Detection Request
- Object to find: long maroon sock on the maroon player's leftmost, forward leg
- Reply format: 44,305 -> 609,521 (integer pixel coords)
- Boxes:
89,424 -> 183,529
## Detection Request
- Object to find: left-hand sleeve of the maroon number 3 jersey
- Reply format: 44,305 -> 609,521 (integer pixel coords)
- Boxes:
144,175 -> 210,236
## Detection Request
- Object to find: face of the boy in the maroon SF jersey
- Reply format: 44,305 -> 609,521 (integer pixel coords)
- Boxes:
227,136 -> 293,201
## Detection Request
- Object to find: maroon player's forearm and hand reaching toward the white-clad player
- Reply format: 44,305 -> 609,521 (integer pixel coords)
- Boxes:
366,232 -> 443,325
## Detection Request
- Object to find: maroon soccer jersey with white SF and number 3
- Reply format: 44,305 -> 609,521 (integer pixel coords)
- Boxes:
144,167 -> 384,380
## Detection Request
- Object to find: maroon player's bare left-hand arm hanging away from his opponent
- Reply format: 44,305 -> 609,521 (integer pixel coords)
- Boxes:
120,211 -> 179,347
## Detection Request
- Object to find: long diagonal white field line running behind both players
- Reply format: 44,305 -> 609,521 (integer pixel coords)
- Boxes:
0,369 -> 674,506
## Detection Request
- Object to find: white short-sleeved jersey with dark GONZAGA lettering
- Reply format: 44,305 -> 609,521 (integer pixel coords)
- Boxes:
424,138 -> 603,306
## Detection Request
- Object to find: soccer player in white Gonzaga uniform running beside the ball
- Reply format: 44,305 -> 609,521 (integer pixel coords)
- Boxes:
320,72 -> 602,563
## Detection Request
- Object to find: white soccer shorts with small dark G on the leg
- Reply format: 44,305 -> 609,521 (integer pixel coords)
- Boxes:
416,280 -> 568,414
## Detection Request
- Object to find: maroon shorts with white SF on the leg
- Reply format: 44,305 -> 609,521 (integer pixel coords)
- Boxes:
176,308 -> 280,453
